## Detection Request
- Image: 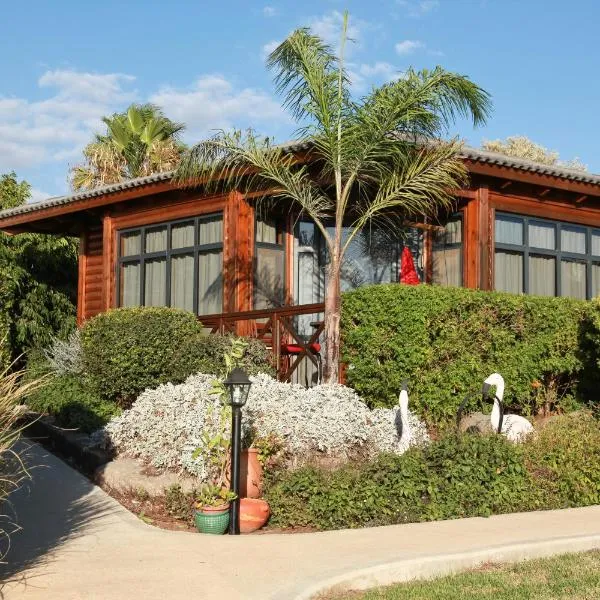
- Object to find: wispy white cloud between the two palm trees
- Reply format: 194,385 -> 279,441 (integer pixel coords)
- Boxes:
149,75 -> 289,141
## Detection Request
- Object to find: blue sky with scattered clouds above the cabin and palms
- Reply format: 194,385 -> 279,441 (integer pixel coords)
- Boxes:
0,0 -> 600,200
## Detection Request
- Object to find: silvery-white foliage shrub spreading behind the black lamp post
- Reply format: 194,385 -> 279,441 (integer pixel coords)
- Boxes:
93,374 -> 428,480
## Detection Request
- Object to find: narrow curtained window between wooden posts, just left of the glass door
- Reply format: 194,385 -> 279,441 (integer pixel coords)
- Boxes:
254,216 -> 285,309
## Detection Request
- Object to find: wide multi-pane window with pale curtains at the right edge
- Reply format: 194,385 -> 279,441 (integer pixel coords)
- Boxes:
494,213 -> 600,299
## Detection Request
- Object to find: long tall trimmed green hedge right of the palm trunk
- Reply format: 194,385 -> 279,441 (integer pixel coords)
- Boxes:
342,284 -> 600,423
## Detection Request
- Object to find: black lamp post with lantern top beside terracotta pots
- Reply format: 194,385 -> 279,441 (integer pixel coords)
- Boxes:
224,367 -> 252,535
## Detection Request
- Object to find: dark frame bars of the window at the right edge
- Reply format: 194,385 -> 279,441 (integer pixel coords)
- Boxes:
494,211 -> 600,300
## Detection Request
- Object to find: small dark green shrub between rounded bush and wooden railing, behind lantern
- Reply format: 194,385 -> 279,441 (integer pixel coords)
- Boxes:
168,334 -> 275,383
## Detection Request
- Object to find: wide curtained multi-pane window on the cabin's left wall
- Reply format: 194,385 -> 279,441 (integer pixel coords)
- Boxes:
117,214 -> 223,315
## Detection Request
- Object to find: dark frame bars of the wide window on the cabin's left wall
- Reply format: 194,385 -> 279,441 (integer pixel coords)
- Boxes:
116,211 -> 225,316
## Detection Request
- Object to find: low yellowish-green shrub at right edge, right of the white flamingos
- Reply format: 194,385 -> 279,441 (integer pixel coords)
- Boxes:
525,412 -> 600,508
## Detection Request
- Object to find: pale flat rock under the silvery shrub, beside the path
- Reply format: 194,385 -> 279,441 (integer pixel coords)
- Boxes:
94,457 -> 198,496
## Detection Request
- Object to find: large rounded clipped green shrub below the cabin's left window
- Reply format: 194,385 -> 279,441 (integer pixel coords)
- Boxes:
81,308 -> 202,406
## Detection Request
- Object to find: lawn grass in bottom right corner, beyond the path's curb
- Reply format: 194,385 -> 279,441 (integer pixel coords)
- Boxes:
321,551 -> 600,600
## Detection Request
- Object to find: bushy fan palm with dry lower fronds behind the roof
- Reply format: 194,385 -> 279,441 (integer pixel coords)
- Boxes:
71,104 -> 185,190
